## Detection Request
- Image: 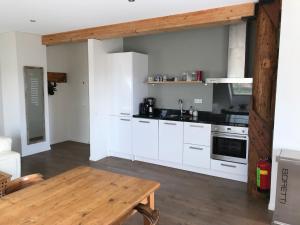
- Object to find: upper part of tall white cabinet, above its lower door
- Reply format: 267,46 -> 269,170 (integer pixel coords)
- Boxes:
108,52 -> 148,116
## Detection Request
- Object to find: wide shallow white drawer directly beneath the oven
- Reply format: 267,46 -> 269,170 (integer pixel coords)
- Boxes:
211,159 -> 248,175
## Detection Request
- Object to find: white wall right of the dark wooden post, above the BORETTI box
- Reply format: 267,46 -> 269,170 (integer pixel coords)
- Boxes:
269,0 -> 300,210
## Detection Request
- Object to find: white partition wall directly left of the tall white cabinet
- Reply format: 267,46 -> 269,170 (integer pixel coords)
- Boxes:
88,39 -> 123,161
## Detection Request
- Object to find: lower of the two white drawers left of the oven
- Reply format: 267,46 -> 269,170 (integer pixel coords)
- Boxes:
183,144 -> 210,169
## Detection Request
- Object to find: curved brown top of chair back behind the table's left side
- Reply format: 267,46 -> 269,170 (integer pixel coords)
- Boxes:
5,173 -> 44,194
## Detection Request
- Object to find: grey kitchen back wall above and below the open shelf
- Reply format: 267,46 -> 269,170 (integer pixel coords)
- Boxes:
124,26 -> 228,111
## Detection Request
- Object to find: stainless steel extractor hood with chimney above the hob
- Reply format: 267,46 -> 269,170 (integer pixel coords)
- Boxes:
205,22 -> 253,84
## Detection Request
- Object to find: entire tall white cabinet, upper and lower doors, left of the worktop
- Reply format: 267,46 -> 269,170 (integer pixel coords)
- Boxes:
107,52 -> 148,159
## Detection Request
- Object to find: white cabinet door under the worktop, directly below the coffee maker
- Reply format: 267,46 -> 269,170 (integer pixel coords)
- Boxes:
132,118 -> 158,160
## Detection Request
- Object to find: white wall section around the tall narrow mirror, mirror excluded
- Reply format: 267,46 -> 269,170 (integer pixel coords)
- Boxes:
0,32 -> 50,156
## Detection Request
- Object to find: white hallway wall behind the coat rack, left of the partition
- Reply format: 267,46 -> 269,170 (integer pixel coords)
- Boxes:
47,42 -> 90,144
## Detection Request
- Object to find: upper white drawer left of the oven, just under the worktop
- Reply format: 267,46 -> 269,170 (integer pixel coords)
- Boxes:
184,122 -> 211,146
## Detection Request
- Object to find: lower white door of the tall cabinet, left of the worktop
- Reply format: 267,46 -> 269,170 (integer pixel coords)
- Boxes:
109,116 -> 132,155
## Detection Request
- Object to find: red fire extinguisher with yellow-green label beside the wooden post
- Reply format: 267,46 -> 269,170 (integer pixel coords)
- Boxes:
256,159 -> 271,192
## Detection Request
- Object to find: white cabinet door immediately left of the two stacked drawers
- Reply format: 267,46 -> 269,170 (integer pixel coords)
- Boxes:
159,120 -> 183,164
